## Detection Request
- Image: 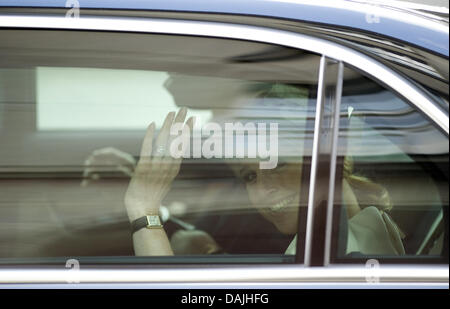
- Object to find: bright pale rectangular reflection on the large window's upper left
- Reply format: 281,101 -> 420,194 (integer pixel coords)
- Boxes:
36,67 -> 211,131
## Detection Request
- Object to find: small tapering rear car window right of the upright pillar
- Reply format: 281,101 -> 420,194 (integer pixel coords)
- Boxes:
333,68 -> 449,262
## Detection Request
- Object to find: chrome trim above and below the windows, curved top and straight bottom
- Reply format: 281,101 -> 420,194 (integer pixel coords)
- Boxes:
0,15 -> 449,288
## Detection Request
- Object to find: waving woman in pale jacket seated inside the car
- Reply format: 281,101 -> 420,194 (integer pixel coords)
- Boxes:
125,108 -> 404,256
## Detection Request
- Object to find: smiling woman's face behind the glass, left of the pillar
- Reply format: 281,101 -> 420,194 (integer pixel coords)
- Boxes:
237,162 -> 302,234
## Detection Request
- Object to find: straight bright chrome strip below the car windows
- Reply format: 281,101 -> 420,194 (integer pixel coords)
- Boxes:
0,264 -> 449,282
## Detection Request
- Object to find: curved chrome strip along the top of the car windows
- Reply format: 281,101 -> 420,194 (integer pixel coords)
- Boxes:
0,15 -> 449,136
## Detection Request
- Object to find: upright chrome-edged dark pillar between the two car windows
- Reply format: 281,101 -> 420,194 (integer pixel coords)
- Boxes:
304,56 -> 343,266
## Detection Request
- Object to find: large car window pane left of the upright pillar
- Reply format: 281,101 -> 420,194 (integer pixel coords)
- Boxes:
0,30 -> 320,263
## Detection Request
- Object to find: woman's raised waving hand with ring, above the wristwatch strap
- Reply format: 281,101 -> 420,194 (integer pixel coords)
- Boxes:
125,108 -> 194,221
